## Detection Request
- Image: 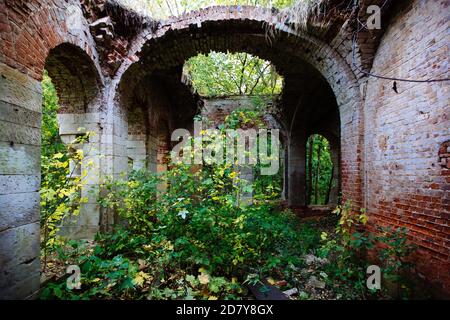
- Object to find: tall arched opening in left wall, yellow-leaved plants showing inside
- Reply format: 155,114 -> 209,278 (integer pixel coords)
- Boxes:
40,43 -> 101,262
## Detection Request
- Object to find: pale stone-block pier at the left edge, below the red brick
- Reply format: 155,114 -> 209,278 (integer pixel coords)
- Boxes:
0,63 -> 42,299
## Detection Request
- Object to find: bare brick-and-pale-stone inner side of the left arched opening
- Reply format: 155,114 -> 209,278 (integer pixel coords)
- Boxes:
45,42 -> 102,239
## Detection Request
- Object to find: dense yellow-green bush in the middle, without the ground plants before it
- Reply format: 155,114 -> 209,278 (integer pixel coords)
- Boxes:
102,165 -> 304,276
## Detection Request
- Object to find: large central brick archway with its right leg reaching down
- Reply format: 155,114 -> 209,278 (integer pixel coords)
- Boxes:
109,7 -> 363,210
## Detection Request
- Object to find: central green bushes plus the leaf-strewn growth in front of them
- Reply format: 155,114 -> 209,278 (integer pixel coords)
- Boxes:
44,165 -> 310,299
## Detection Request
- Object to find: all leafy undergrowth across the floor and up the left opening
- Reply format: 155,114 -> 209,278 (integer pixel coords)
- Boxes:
41,77 -> 412,299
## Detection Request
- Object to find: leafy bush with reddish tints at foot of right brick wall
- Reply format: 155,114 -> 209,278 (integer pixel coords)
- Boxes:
319,201 -> 413,299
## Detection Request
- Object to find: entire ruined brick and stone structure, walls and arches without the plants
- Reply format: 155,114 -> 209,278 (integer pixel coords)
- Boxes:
0,0 -> 450,298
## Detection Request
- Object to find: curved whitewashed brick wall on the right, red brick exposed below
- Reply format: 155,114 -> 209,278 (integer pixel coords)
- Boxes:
365,0 -> 450,294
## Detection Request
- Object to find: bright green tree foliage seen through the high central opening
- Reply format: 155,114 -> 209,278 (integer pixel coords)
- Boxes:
185,52 -> 283,97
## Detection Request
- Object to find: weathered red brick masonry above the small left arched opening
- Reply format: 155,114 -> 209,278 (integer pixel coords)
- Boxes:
0,0 -> 97,79
